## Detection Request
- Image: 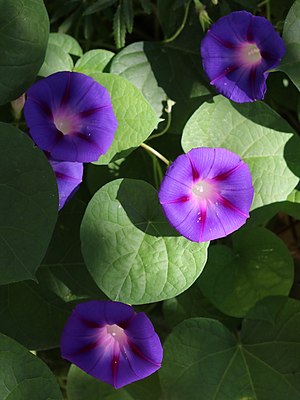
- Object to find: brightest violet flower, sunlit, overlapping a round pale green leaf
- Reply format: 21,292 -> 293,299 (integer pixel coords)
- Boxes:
158,147 -> 254,242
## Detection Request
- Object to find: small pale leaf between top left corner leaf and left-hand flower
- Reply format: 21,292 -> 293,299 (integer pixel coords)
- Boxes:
39,42 -> 74,77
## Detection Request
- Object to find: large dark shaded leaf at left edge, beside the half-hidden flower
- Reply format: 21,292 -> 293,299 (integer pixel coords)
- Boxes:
0,123 -> 58,284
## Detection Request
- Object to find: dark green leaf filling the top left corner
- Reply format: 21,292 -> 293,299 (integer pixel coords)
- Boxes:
0,0 -> 49,104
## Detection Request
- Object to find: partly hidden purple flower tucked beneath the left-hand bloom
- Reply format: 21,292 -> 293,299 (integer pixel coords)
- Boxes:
49,160 -> 83,210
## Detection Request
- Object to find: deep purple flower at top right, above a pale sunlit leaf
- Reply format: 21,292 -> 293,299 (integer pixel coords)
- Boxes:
201,11 -> 285,103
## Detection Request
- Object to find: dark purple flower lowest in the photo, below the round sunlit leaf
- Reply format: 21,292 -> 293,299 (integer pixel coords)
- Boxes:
60,301 -> 163,388
